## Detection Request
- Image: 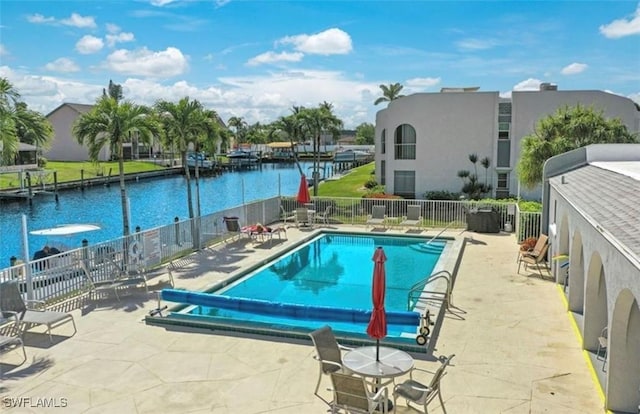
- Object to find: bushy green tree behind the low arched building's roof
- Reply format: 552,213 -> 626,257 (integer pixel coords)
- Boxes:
517,105 -> 638,189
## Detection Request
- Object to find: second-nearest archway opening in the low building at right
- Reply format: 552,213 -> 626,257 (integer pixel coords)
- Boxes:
582,252 -> 608,351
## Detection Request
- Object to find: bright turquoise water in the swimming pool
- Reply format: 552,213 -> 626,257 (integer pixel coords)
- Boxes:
172,233 -> 446,342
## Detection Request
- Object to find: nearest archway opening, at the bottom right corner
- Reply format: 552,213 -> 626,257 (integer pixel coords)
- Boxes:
606,289 -> 640,413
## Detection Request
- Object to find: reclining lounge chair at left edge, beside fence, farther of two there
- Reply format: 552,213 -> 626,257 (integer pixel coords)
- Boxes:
0,281 -> 77,342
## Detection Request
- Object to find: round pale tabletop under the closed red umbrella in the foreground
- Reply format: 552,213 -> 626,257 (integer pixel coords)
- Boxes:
342,346 -> 413,378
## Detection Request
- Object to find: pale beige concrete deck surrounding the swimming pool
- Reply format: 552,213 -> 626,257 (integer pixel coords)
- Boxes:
0,227 -> 604,414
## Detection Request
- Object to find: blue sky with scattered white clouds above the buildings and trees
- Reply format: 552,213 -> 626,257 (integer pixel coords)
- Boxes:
0,0 -> 640,128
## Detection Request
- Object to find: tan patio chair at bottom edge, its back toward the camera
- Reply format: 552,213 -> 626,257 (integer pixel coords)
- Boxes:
330,372 -> 389,414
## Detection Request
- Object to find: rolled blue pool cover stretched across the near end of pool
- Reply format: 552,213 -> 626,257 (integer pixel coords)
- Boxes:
161,289 -> 420,326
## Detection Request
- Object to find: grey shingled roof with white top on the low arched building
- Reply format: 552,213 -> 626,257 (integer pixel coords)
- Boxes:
549,160 -> 640,261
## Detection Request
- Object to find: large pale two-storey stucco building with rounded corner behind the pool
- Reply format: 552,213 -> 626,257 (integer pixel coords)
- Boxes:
375,84 -> 640,200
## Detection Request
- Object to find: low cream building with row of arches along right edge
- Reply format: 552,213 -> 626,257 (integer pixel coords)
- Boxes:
536,144 -> 640,413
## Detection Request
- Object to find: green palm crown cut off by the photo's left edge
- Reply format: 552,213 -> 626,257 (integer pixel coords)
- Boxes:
0,78 -> 53,165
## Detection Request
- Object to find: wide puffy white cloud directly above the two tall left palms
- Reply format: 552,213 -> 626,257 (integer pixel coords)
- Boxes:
105,47 -> 188,78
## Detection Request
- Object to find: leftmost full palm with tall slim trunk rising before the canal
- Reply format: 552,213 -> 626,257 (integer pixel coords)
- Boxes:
73,96 -> 158,236
